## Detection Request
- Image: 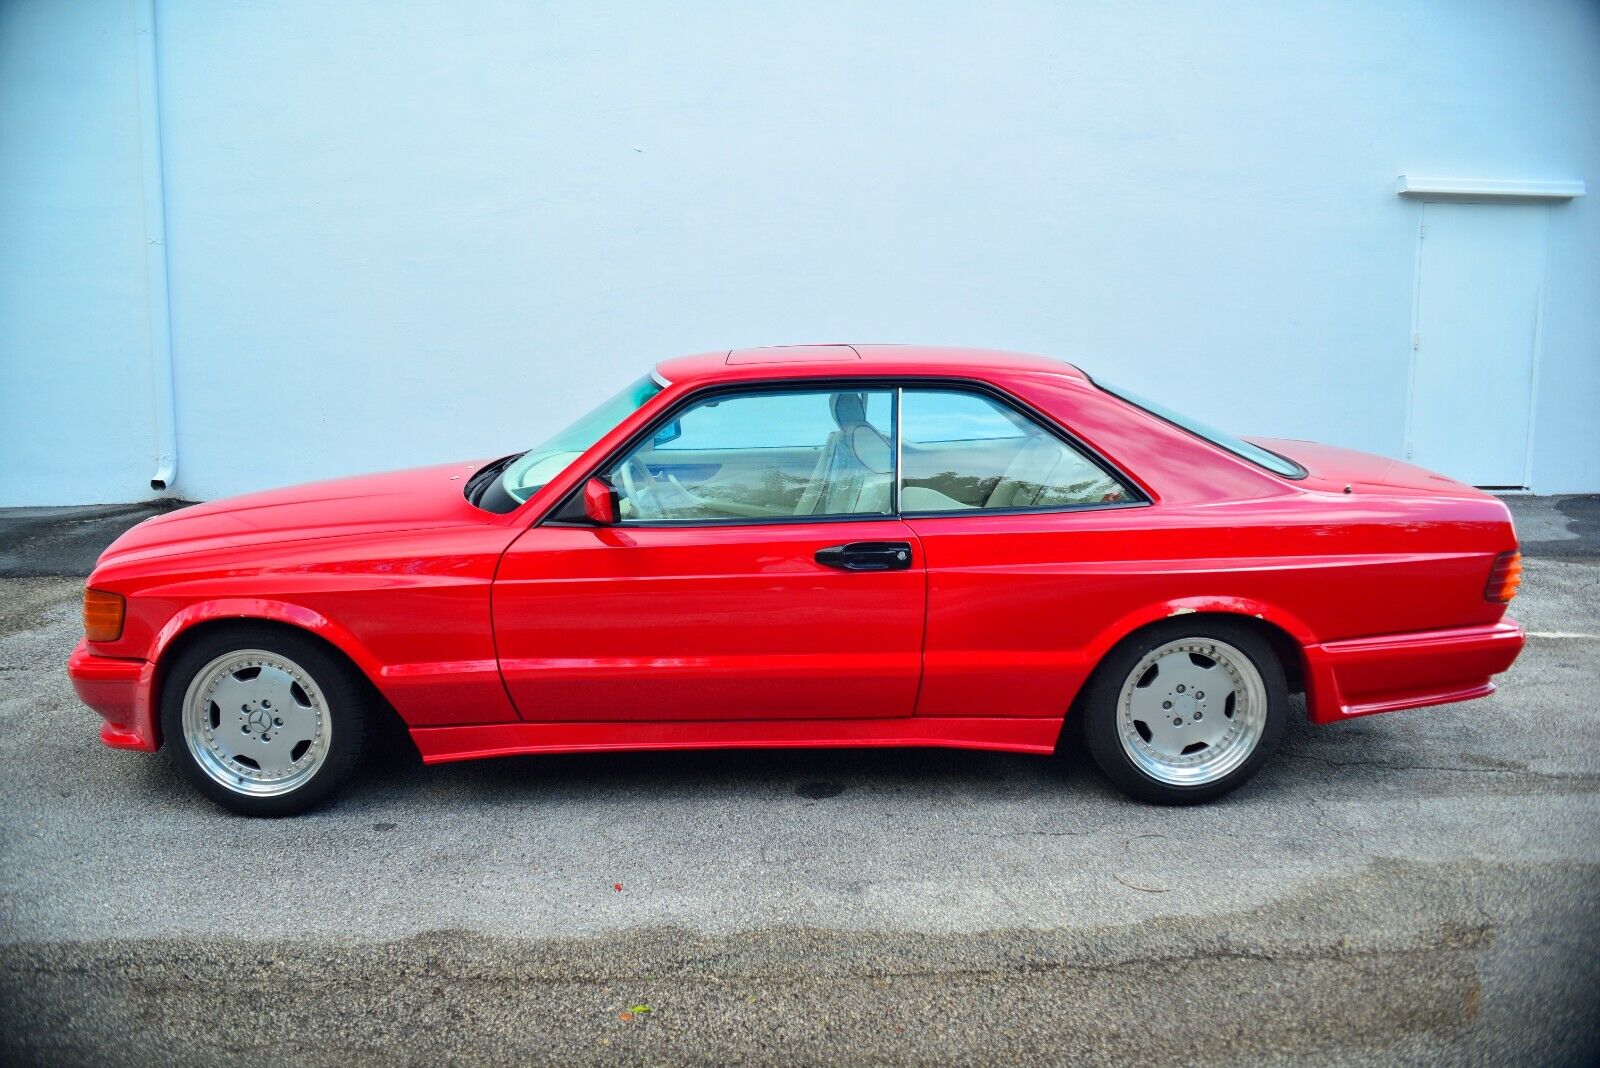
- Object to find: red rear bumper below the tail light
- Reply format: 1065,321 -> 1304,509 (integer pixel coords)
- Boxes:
1306,617 -> 1523,723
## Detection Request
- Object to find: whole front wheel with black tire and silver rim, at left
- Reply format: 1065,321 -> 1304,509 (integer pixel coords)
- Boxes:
162,625 -> 366,815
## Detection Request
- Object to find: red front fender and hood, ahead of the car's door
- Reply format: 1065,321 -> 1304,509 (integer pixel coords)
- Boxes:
76,464 -> 517,737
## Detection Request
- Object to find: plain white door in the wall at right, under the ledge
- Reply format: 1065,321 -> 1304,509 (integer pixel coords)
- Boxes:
1406,203 -> 1546,488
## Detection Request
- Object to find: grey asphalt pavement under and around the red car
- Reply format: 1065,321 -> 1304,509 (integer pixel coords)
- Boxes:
0,497 -> 1600,1065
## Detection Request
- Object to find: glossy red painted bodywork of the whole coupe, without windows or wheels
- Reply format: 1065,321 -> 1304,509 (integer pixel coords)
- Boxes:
69,345 -> 1522,761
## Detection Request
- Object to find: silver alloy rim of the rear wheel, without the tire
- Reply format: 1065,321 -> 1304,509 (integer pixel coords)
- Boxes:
1117,638 -> 1267,787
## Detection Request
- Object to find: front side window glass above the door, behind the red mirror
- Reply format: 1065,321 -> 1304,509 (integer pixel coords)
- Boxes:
605,390 -> 894,523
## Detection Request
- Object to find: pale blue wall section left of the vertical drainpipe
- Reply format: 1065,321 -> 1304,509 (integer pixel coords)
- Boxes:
0,2 -> 154,505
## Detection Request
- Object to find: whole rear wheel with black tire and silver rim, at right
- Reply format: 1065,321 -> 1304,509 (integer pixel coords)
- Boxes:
1083,620 -> 1288,804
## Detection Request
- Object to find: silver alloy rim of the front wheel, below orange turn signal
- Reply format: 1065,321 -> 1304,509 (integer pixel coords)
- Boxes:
184,649 -> 333,798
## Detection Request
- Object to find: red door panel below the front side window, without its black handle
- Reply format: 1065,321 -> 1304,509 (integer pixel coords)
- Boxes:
494,520 -> 926,721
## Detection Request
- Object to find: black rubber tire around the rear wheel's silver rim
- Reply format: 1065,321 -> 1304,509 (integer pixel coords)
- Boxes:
1080,617 -> 1290,804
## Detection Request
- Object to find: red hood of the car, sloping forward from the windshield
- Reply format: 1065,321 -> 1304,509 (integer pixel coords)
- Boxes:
99,460 -> 494,564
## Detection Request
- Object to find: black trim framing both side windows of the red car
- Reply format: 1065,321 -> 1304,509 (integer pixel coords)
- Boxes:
534,374 -> 1152,529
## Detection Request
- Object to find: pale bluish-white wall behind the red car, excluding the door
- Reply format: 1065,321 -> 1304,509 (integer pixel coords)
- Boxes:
0,0 -> 1600,504
